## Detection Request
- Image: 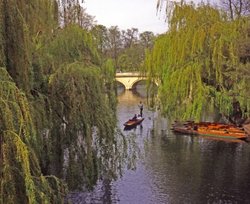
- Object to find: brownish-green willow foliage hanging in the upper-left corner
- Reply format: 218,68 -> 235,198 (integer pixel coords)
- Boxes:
0,0 -> 57,93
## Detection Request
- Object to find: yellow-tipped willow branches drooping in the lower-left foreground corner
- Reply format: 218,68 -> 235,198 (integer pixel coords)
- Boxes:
0,68 -> 66,203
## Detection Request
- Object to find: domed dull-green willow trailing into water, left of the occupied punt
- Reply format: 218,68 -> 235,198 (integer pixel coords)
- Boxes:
49,62 -> 116,189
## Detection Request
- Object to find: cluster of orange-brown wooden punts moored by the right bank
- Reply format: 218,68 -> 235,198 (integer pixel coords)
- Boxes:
172,121 -> 247,139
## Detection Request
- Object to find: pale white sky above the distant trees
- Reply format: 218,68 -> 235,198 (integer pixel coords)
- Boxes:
83,0 -> 167,34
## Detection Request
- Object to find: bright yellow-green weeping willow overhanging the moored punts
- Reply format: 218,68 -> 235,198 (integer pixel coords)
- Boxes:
146,1 -> 250,122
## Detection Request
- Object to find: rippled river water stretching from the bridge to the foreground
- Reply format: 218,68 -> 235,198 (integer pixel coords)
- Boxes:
68,88 -> 250,204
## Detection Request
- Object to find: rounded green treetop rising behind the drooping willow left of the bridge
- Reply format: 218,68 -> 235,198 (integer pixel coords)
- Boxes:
41,25 -> 99,74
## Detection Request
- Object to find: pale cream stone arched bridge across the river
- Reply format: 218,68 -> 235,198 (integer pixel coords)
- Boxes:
115,72 -> 147,89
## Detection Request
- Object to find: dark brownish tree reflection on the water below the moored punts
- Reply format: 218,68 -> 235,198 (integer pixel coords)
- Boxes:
145,126 -> 250,203
